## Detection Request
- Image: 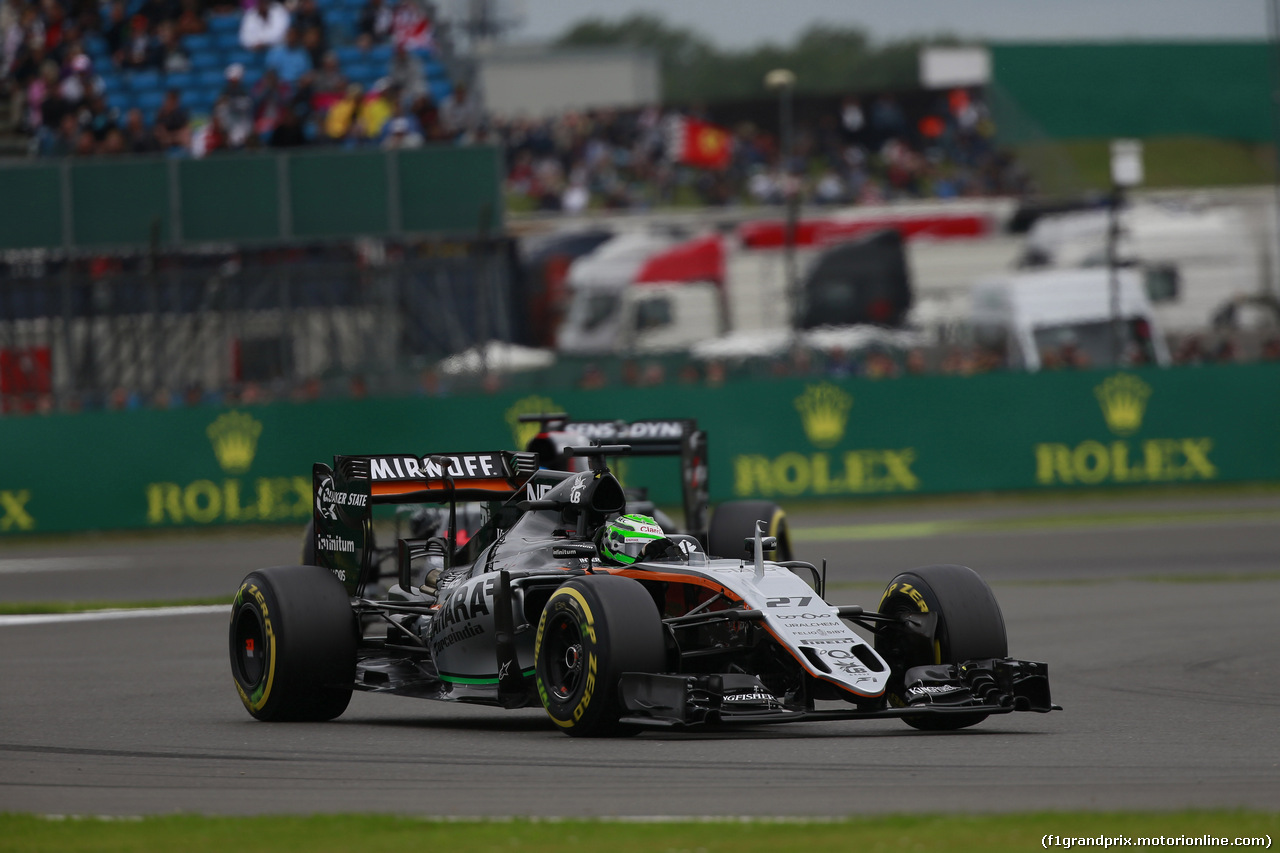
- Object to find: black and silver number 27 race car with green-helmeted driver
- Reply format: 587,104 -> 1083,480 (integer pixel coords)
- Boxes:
229,446 -> 1057,735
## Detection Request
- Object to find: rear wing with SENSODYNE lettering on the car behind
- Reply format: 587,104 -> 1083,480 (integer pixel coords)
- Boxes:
521,412 -> 710,537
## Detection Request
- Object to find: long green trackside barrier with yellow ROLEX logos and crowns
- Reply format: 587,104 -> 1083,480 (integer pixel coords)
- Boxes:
0,364 -> 1280,535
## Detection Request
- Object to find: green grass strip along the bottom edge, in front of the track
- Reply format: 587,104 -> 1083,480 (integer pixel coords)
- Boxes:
0,811 -> 1280,853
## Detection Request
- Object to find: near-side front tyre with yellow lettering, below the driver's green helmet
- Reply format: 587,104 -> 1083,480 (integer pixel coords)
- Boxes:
534,575 -> 666,738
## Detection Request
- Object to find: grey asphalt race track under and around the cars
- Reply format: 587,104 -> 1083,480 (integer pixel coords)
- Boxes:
0,492 -> 1280,816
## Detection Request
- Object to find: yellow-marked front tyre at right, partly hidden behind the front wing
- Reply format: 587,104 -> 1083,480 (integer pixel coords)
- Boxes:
876,566 -> 1009,730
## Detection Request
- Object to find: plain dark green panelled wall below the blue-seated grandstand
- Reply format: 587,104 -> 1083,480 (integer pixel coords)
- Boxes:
0,145 -> 503,251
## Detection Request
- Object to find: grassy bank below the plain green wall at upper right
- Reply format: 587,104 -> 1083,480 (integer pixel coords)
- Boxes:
1015,137 -> 1275,195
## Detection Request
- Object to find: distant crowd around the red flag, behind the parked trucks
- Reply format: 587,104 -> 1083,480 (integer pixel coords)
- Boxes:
488,90 -> 1030,213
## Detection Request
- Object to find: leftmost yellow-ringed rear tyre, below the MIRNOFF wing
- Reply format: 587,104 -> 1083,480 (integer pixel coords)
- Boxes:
229,566 -> 358,721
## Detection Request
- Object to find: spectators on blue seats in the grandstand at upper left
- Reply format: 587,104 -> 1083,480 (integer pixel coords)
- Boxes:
0,0 -> 456,156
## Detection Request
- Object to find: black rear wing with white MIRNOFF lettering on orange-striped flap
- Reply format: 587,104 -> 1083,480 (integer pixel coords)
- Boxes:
311,451 -> 538,596
